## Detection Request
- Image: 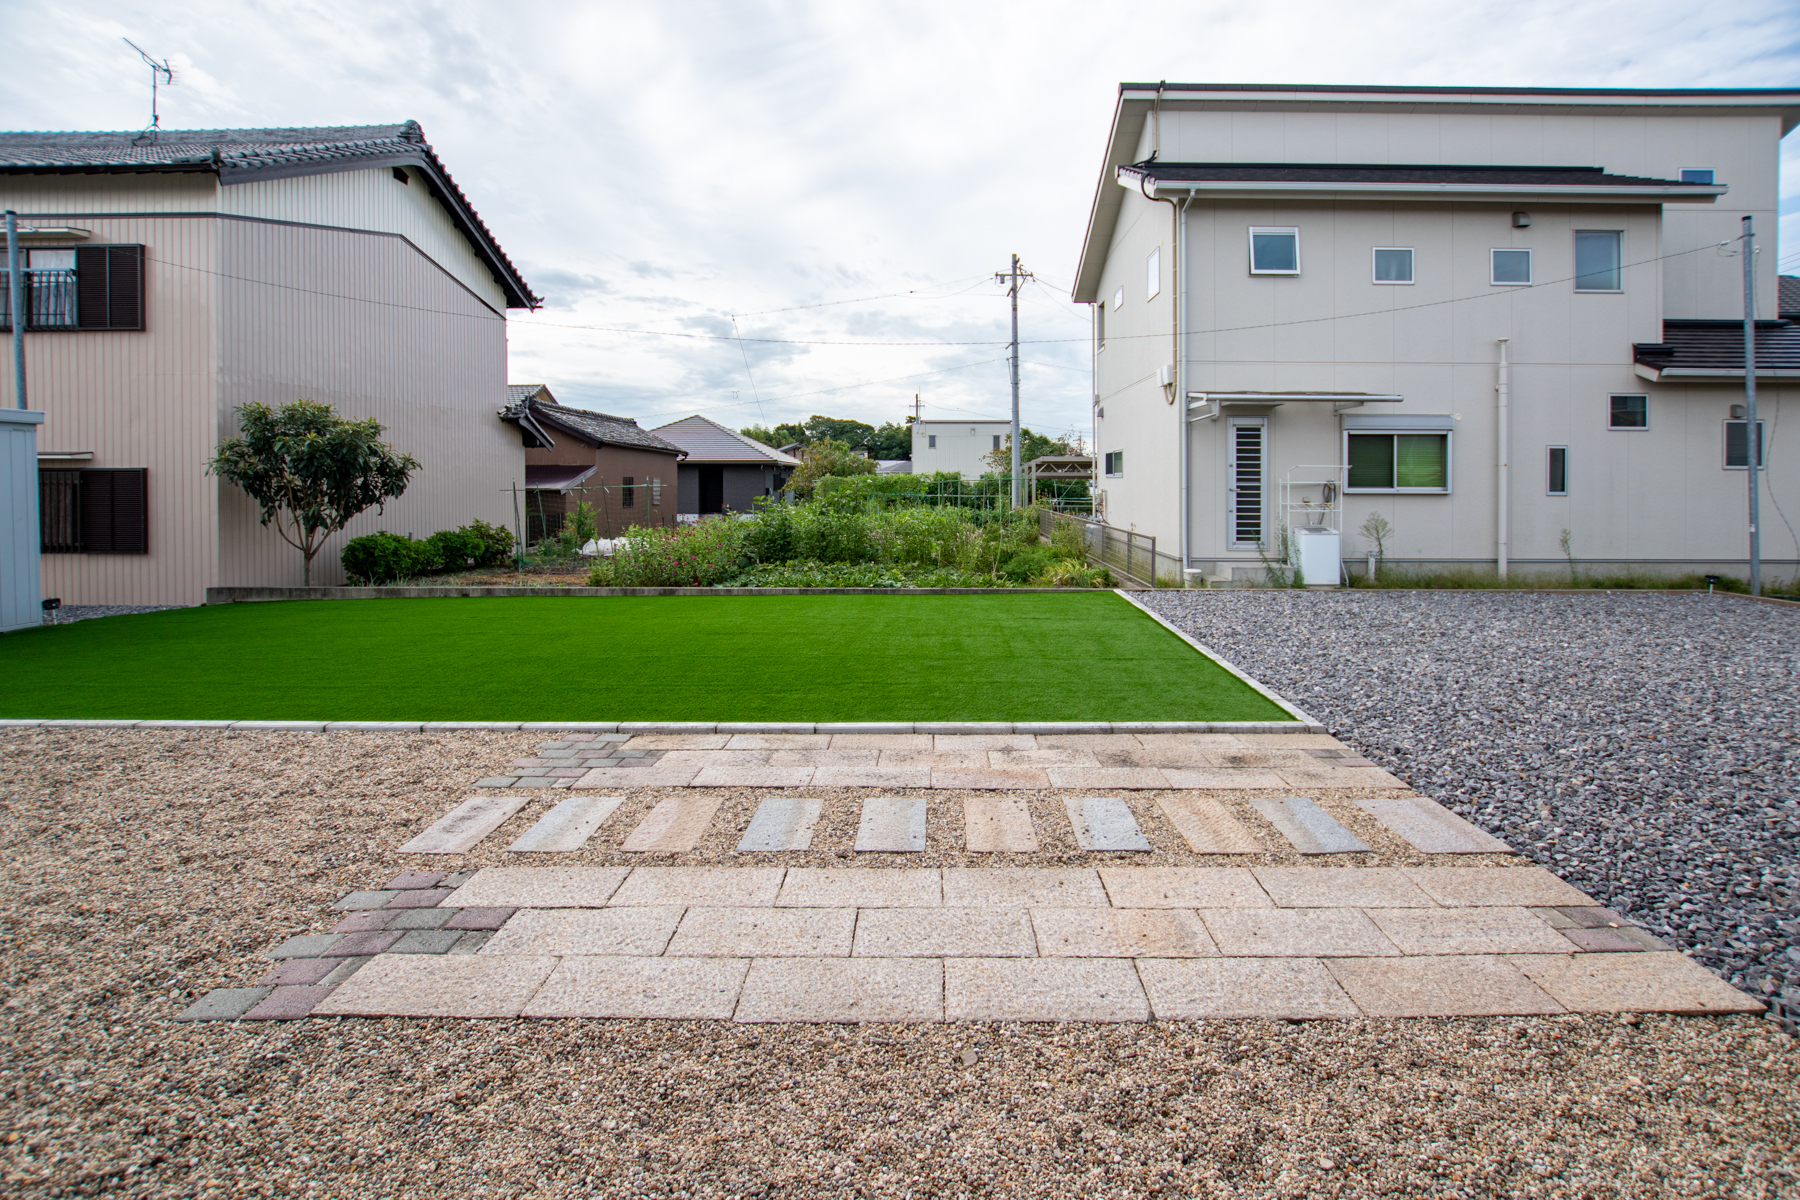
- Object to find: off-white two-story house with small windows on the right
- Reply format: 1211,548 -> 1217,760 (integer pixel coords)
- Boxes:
1075,85 -> 1800,583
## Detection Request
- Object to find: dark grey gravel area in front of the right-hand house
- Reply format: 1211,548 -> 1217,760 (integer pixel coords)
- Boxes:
1139,590 -> 1800,1031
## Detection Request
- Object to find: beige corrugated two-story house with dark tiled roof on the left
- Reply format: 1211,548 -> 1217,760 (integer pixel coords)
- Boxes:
0,122 -> 538,604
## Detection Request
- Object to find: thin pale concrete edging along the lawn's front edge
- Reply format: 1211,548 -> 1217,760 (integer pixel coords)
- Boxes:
0,719 -> 1325,734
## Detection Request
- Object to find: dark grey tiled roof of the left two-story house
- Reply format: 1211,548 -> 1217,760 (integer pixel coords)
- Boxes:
0,121 -> 542,308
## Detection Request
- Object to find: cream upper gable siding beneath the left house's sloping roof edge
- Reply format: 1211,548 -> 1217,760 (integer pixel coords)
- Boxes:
220,167 -> 506,316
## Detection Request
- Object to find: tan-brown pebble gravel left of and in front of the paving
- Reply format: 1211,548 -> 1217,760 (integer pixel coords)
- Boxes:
0,730 -> 1800,1200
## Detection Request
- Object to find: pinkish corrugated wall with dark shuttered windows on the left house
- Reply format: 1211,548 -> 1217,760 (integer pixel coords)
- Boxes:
0,212 -> 218,604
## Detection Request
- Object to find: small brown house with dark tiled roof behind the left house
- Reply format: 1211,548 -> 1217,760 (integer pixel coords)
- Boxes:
500,383 -> 686,542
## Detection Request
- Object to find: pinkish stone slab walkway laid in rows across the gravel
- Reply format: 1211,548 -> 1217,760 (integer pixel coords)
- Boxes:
184,734 -> 1762,1022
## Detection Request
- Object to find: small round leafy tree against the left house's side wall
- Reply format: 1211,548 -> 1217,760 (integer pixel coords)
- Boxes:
207,399 -> 419,587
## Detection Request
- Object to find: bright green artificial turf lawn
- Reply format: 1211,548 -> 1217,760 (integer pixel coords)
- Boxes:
0,592 -> 1292,721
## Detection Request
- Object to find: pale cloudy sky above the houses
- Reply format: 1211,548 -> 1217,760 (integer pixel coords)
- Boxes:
0,0 -> 1800,434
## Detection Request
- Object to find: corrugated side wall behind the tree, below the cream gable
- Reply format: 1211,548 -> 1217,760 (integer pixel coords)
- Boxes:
218,218 -> 524,587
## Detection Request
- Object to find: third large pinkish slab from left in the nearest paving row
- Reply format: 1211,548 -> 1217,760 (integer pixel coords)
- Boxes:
736,959 -> 943,1022
